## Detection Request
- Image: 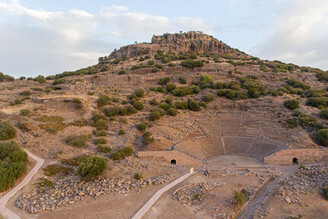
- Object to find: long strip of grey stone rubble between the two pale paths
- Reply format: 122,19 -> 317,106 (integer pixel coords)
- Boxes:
16,174 -> 175,214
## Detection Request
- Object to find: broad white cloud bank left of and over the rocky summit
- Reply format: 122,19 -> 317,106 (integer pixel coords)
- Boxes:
0,0 -> 215,77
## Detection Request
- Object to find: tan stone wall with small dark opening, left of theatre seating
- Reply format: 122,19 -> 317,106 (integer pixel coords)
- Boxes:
137,151 -> 203,166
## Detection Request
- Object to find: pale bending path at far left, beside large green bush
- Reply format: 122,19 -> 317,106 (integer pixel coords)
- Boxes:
0,150 -> 44,219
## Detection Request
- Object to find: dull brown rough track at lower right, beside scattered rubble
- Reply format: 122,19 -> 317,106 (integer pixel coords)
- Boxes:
236,167 -> 298,219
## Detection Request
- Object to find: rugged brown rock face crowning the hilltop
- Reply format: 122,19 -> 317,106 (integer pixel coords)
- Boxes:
106,31 -> 247,59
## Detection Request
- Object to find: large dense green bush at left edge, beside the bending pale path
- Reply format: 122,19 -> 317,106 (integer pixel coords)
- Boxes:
0,142 -> 27,192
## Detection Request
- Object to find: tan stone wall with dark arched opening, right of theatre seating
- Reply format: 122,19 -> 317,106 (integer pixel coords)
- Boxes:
264,149 -> 328,165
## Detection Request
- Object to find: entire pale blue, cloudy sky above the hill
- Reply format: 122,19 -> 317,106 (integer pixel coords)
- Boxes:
0,0 -> 328,77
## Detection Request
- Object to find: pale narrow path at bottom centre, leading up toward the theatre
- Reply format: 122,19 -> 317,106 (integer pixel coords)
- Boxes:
132,172 -> 197,219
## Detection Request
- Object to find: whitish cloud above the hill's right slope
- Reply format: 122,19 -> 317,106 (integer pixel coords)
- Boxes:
257,0 -> 328,69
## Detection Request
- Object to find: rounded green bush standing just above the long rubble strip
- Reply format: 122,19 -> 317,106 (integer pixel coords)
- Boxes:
78,156 -> 107,179
